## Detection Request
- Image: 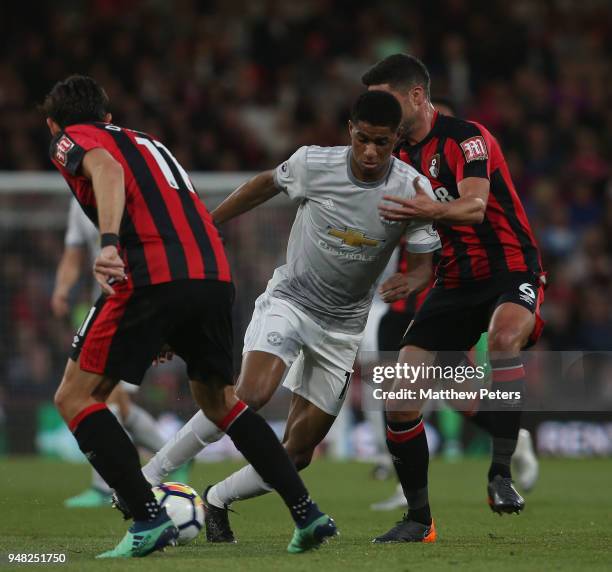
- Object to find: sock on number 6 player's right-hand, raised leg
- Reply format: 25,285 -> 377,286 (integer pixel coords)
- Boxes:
488,356 -> 525,481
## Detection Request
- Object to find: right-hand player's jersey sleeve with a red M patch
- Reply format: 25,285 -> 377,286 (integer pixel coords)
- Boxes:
444,121 -> 492,183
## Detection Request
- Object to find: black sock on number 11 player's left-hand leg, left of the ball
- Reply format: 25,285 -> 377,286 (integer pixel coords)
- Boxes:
69,403 -> 159,520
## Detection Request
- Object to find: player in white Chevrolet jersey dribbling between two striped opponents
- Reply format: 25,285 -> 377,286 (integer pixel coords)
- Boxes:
131,91 -> 440,542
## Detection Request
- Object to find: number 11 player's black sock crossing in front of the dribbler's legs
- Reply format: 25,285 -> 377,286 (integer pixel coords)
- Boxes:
219,401 -> 323,527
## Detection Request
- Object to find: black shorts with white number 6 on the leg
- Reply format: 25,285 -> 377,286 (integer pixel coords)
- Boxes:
401,272 -> 544,352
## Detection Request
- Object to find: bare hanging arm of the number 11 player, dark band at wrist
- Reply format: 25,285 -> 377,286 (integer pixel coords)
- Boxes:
82,148 -> 126,296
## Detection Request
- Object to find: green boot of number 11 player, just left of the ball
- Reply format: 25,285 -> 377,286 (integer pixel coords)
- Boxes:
96,508 -> 179,558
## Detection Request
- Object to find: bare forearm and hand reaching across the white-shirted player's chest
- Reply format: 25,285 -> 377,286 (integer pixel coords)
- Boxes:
379,177 -> 490,225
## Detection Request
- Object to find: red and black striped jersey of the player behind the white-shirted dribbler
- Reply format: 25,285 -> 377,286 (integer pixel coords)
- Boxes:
398,112 -> 542,288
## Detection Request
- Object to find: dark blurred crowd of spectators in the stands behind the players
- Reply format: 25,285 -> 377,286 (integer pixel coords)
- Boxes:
0,0 -> 612,450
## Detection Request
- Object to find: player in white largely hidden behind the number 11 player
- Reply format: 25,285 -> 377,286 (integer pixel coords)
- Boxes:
51,199 -> 175,508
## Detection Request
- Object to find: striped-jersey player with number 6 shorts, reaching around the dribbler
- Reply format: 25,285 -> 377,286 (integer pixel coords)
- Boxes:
362,54 -> 543,542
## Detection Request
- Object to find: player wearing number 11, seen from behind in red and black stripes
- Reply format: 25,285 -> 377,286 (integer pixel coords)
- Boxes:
42,76 -> 335,558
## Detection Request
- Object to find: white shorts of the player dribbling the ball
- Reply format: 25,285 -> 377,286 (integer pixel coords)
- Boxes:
242,291 -> 363,417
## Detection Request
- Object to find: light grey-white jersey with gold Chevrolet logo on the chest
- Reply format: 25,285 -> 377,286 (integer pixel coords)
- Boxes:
268,146 -> 440,333
